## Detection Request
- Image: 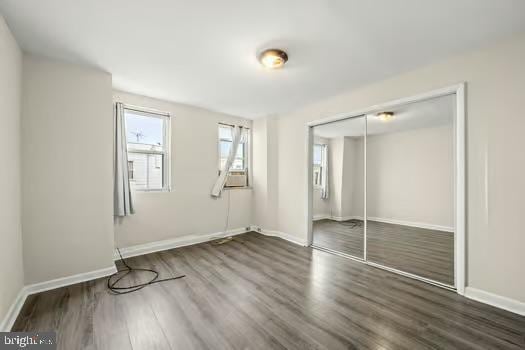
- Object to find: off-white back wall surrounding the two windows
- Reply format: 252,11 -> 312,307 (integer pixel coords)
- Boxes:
113,91 -> 253,247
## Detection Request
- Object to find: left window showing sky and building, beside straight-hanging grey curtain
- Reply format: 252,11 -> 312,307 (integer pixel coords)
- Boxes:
124,107 -> 170,191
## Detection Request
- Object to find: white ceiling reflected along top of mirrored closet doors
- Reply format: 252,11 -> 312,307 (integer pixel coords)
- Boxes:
314,95 -> 456,138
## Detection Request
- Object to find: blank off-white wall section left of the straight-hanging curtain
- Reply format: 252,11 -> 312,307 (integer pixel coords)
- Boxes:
22,55 -> 113,283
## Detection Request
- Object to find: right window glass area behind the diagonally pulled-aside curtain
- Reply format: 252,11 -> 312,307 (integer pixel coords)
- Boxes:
218,124 -> 249,187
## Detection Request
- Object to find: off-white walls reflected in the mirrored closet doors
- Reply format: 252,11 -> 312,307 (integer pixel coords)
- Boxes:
322,125 -> 454,230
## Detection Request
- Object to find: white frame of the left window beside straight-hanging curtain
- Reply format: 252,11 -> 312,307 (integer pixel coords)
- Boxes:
123,104 -> 172,192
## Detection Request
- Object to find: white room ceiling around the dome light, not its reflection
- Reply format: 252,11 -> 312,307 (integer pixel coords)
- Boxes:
0,0 -> 525,118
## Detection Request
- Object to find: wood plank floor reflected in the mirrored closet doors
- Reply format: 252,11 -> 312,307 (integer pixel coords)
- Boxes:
313,220 -> 454,286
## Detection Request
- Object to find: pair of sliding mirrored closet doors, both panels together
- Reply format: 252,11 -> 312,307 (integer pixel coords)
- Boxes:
311,94 -> 456,288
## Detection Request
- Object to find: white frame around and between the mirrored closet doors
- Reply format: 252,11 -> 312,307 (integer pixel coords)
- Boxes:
305,82 -> 466,295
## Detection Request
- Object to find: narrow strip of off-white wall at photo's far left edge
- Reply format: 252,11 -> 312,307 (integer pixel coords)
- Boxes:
0,16 -> 24,330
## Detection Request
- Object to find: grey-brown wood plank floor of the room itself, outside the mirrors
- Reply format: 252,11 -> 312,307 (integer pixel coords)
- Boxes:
13,233 -> 525,350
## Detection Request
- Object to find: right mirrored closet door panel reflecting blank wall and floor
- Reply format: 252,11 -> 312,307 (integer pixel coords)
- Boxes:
366,95 -> 455,286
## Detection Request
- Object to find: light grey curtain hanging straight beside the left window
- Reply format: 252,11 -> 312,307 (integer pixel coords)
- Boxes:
114,103 -> 135,216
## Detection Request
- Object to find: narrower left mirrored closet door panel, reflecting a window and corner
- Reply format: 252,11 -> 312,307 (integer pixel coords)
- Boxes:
313,116 -> 365,258
